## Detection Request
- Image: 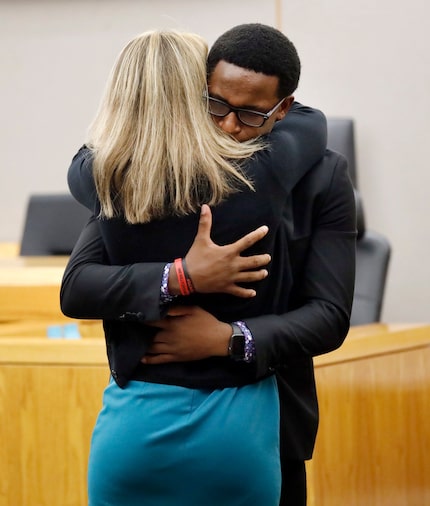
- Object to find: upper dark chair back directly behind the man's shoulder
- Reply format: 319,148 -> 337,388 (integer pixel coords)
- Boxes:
327,118 -> 358,188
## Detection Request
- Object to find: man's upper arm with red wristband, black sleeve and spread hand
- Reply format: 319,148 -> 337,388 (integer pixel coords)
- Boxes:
60,205 -> 270,321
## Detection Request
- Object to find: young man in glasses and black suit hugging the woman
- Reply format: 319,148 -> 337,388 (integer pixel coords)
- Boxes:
62,24 -> 355,506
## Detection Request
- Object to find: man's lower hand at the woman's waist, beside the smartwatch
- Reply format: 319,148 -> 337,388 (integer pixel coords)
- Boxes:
142,306 -> 231,365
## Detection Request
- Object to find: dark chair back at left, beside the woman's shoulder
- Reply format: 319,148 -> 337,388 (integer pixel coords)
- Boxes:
19,193 -> 90,256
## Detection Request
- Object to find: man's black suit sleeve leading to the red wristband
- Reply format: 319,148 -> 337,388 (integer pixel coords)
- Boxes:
60,217 -> 165,321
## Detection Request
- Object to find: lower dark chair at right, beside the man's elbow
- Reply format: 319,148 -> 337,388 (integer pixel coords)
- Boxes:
351,191 -> 391,325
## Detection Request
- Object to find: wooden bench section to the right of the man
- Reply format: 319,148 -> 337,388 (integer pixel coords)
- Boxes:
308,325 -> 430,506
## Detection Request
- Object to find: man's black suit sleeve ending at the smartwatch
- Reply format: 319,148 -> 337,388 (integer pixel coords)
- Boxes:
246,157 -> 356,376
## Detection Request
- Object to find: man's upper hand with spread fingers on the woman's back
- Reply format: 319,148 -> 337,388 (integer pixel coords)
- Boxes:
169,204 -> 271,298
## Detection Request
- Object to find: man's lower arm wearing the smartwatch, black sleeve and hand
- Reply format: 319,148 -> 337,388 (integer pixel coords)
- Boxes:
144,152 -> 356,370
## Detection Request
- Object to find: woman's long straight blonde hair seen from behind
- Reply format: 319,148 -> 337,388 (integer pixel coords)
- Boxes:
87,30 -> 263,223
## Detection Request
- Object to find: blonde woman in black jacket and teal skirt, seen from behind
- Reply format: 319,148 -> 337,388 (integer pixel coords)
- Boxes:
62,31 -> 330,506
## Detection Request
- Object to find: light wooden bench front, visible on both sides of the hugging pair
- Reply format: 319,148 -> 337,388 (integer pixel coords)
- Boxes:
0,325 -> 430,506
